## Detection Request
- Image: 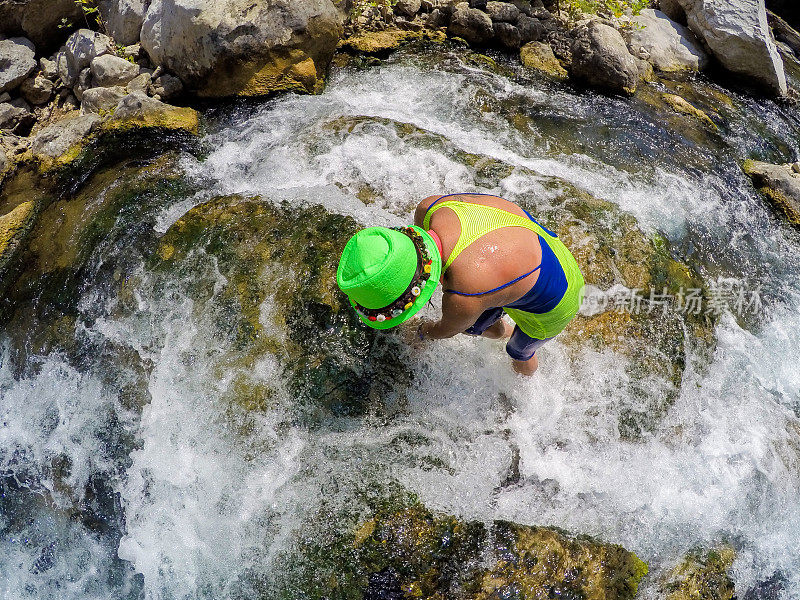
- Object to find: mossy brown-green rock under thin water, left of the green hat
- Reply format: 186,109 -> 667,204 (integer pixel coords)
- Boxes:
157,196 -> 412,420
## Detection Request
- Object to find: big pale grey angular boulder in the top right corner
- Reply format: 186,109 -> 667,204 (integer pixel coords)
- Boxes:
665,0 -> 788,96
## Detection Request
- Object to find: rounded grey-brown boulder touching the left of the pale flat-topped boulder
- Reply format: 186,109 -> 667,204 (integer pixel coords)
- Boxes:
571,21 -> 640,94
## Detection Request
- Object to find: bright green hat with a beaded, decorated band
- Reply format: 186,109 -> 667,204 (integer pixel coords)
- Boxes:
336,227 -> 442,329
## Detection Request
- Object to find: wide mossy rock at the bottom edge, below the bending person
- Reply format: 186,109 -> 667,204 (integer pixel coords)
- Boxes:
288,501 -> 647,600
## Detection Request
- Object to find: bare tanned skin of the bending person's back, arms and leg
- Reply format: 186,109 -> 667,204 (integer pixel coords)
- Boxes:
414,194 -> 542,375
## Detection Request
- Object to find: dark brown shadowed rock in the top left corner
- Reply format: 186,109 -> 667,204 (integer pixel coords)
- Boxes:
0,0 -> 82,52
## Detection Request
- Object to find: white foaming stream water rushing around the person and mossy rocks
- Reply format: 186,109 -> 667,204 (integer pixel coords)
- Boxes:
0,47 -> 800,599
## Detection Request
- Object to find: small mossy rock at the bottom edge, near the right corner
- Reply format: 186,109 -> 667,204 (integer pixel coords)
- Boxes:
660,545 -> 736,600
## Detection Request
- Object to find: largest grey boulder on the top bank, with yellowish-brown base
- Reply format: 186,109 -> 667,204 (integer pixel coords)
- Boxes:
141,0 -> 341,97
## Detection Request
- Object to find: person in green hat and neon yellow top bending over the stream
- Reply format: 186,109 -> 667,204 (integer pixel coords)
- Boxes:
336,194 -> 584,375
